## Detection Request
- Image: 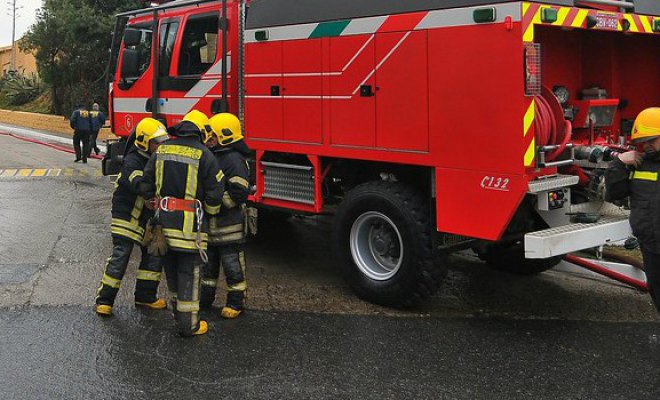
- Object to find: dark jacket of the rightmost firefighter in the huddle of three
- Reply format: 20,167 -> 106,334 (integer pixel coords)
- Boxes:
209,140 -> 250,245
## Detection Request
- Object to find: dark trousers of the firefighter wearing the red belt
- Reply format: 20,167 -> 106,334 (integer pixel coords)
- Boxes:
163,249 -> 202,336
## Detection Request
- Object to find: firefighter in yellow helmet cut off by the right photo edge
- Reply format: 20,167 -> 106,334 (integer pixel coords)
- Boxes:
605,107 -> 660,311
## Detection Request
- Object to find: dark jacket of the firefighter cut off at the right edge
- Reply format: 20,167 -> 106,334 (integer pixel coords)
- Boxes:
605,153 -> 660,253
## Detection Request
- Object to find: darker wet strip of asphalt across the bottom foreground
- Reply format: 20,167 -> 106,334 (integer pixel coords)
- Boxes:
0,307 -> 660,400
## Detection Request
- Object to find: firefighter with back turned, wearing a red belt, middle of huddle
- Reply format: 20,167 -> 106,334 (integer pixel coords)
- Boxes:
140,110 -> 223,336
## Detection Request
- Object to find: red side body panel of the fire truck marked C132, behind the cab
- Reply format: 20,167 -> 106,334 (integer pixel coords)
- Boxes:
245,3 -> 528,240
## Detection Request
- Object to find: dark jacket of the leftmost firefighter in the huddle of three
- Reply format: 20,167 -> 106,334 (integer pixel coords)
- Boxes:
111,146 -> 153,244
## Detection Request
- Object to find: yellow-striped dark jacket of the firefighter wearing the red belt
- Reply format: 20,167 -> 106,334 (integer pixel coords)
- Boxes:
140,122 -> 224,252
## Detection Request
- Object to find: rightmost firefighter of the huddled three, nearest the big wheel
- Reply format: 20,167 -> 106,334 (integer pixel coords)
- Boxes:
201,113 -> 250,319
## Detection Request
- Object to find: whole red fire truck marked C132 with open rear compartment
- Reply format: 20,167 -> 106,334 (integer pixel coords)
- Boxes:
106,0 -> 660,306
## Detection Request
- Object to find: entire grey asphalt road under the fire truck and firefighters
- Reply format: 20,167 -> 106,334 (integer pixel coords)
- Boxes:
0,130 -> 660,399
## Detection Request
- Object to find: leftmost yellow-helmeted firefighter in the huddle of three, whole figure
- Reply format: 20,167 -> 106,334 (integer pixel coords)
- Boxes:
96,118 -> 168,316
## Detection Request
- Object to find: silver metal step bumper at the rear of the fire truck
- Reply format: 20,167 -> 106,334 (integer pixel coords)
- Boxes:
525,216 -> 632,258
